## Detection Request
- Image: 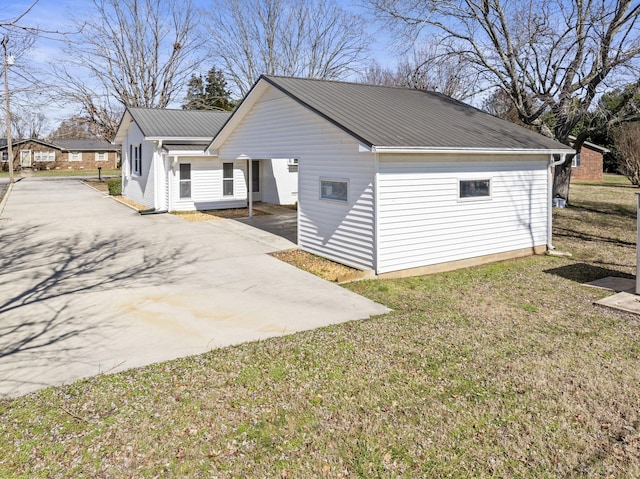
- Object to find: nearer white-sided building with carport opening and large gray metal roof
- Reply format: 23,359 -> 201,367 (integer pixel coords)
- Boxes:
208,76 -> 574,275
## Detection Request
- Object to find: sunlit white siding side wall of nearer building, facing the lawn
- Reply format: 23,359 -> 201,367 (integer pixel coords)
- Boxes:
377,155 -> 548,273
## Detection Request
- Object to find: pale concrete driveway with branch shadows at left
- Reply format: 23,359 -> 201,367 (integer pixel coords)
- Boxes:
0,178 -> 388,397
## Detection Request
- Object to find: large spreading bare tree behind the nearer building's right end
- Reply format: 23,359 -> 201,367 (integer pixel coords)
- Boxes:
369,0 -> 640,199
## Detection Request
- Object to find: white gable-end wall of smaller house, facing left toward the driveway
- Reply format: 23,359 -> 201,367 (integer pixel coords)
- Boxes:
122,123 -> 156,208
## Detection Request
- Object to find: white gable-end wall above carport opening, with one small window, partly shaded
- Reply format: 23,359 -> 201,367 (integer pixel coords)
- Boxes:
218,88 -> 375,269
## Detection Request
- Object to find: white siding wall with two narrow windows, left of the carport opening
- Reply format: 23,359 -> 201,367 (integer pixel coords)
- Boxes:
169,157 -> 247,211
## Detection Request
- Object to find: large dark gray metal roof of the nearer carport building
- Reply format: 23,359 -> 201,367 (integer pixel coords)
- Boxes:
262,76 -> 570,150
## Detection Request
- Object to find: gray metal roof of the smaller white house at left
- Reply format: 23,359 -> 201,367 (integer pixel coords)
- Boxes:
128,108 -> 231,138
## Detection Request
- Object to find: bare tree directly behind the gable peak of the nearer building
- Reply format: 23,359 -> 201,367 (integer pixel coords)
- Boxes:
209,0 -> 369,96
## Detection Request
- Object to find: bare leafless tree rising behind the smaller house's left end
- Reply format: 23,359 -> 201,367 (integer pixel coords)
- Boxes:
57,0 -> 203,139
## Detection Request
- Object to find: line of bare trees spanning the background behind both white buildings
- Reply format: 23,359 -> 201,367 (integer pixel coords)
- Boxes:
0,0 -> 640,199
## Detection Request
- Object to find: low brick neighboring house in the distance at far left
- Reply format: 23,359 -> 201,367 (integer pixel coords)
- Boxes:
0,138 -> 120,171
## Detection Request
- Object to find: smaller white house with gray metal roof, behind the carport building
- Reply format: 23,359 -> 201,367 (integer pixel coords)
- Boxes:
114,108 -> 298,215
